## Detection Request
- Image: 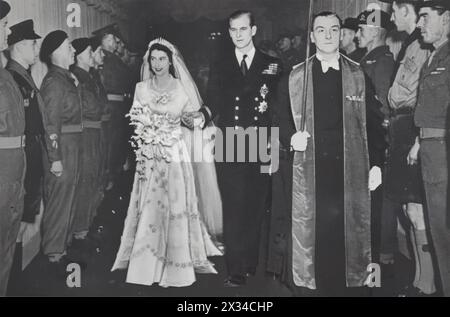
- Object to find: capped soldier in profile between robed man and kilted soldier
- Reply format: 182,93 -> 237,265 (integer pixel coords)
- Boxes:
356,10 -> 395,119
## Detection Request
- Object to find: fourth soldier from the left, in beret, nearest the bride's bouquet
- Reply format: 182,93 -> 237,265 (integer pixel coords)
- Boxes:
72,38 -> 103,247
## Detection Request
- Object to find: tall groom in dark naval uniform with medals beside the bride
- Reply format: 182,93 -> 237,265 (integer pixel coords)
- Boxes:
191,11 -> 279,287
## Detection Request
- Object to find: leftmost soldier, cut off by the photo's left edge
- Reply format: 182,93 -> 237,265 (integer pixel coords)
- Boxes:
0,1 -> 25,296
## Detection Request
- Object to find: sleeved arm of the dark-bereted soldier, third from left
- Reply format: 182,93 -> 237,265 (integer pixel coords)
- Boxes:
41,79 -> 64,163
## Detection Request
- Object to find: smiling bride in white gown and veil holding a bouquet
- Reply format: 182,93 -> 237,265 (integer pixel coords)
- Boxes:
112,39 -> 222,287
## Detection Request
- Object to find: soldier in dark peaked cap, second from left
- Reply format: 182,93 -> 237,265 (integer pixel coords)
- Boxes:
6,20 -> 45,223
